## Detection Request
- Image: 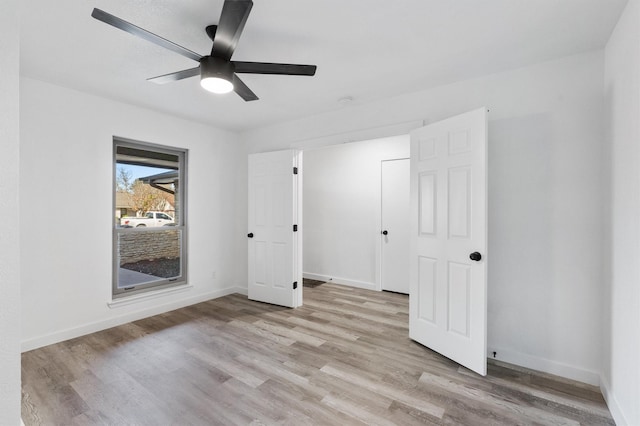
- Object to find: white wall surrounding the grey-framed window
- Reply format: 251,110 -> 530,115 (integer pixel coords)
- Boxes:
20,78 -> 246,350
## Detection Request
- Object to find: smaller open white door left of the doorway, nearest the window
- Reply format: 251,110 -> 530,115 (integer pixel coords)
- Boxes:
247,150 -> 302,308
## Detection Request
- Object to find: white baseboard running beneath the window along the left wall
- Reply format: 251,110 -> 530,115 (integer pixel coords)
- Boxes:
21,287 -> 240,352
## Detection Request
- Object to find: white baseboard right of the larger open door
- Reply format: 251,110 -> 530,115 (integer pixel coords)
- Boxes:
487,347 -> 600,386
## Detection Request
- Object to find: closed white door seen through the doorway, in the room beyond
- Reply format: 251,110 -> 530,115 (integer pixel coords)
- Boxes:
380,158 -> 410,294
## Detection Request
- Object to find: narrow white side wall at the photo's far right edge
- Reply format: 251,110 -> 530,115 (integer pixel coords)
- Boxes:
603,1 -> 640,425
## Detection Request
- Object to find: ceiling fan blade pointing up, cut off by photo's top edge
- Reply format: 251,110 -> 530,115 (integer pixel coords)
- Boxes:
211,0 -> 253,60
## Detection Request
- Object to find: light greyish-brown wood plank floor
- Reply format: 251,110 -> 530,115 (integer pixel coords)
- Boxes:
22,283 -> 614,425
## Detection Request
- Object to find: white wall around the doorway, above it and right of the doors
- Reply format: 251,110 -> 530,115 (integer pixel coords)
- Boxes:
238,51 -> 604,384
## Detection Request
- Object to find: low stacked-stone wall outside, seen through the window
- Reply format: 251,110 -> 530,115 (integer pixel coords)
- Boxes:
119,229 -> 180,265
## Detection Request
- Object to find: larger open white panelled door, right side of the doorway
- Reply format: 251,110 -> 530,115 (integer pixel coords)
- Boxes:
409,108 -> 487,375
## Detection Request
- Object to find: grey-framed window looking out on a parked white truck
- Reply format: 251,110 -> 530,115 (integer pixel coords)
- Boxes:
113,138 -> 187,298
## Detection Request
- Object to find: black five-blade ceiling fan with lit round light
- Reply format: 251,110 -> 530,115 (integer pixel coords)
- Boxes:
91,0 -> 317,101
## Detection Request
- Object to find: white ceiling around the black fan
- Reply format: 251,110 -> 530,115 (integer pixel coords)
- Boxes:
21,0 -> 627,130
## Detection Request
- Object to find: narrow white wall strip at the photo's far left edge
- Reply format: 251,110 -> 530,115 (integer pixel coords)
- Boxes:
0,0 -> 20,425
